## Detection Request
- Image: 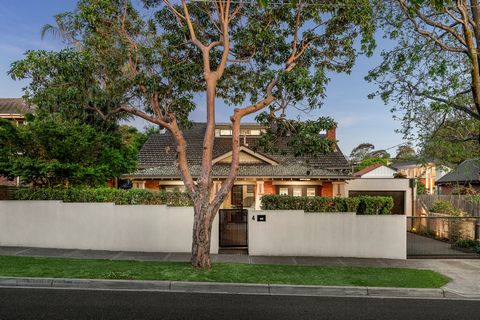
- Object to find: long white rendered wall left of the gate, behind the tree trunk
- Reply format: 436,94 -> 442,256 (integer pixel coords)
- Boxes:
0,201 -> 219,253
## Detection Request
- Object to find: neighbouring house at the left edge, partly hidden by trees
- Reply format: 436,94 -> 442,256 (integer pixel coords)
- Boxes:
0,98 -> 32,186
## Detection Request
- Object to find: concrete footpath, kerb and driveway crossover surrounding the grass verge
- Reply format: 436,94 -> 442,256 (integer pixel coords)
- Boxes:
0,246 -> 480,299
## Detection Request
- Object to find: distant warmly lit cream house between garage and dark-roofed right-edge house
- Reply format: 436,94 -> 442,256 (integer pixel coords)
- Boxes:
390,160 -> 448,194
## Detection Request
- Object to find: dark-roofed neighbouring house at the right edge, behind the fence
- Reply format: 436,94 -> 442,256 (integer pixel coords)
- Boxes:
437,158 -> 480,194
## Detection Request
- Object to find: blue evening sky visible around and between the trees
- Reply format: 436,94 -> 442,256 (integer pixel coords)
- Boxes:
0,0 -> 403,155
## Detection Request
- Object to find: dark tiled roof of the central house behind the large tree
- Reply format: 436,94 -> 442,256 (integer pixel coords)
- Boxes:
125,123 -> 351,178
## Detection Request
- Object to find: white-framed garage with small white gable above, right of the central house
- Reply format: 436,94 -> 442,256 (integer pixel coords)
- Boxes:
346,163 -> 416,216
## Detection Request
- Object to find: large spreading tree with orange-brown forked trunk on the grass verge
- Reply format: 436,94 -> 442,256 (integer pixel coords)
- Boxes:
11,0 -> 374,268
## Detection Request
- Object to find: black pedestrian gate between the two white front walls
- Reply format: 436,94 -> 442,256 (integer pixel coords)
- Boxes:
219,209 -> 248,248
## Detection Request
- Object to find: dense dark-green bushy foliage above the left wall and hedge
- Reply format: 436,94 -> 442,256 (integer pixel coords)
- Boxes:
0,112 -> 138,186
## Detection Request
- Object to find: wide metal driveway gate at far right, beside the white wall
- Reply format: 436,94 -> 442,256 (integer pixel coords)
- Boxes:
407,215 -> 480,259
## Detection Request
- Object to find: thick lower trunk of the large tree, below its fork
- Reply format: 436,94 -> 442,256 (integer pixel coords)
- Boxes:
191,206 -> 214,269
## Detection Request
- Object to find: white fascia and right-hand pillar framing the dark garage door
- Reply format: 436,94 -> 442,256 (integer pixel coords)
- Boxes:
346,178 -> 416,216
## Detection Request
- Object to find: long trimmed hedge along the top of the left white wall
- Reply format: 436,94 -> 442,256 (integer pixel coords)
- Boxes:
14,188 -> 192,207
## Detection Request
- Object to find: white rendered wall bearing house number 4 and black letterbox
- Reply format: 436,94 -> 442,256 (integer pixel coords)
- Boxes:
248,210 -> 407,259
